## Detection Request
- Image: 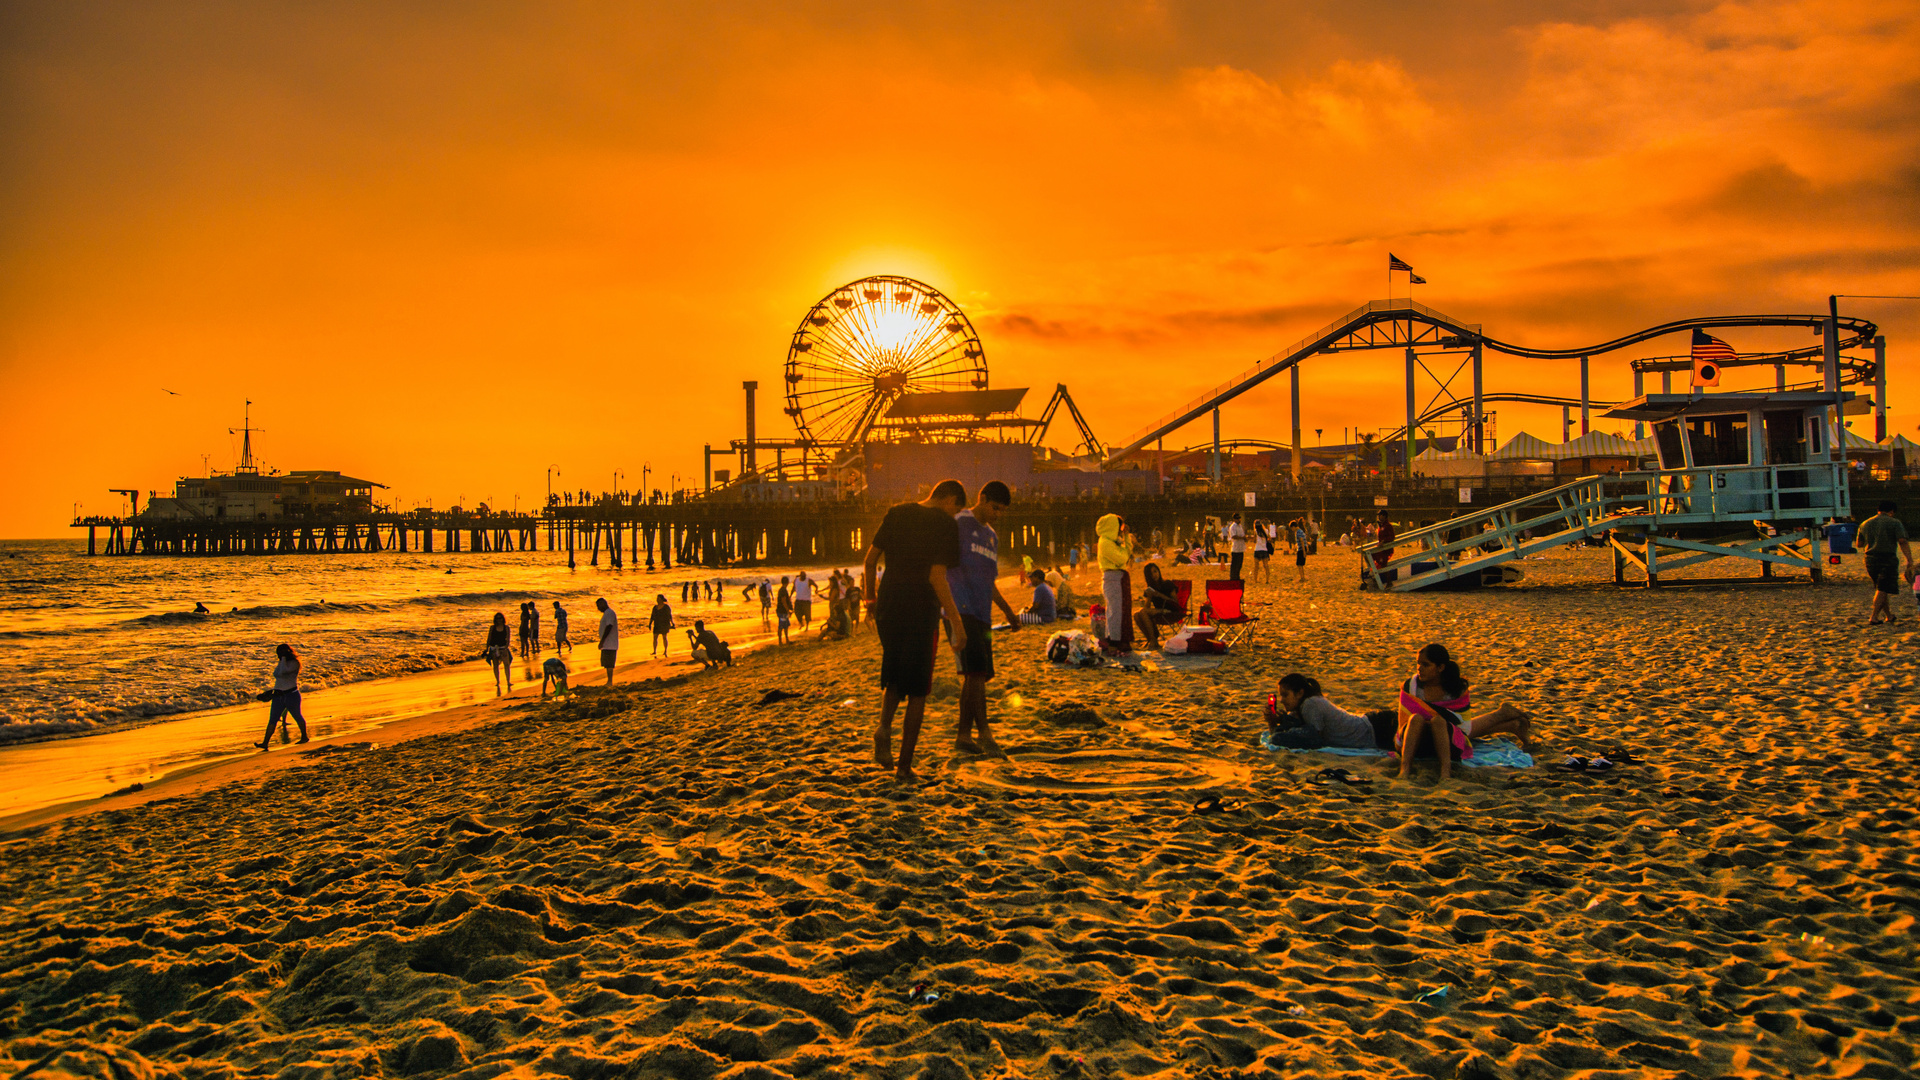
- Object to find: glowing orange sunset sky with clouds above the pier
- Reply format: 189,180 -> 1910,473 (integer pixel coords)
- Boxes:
0,0 -> 1920,536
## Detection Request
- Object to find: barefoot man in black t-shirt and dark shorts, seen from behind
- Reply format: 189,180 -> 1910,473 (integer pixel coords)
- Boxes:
862,480 -> 966,780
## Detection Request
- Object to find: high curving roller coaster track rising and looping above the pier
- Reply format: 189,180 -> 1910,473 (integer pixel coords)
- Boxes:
1106,300 -> 1878,465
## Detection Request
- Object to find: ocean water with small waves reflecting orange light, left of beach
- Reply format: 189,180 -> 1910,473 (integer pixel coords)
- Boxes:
0,540 -> 817,744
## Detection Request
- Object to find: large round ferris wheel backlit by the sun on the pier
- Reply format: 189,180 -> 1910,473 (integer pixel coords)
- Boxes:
787,275 -> 987,446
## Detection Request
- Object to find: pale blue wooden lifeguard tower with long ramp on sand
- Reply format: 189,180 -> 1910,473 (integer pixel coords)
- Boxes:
1359,390 -> 1853,592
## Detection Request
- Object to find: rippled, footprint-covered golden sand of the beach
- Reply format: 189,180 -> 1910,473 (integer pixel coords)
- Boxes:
0,550 -> 1920,1080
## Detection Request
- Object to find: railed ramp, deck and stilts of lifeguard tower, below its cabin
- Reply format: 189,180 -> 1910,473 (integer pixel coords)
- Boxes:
1357,461 -> 1853,592
